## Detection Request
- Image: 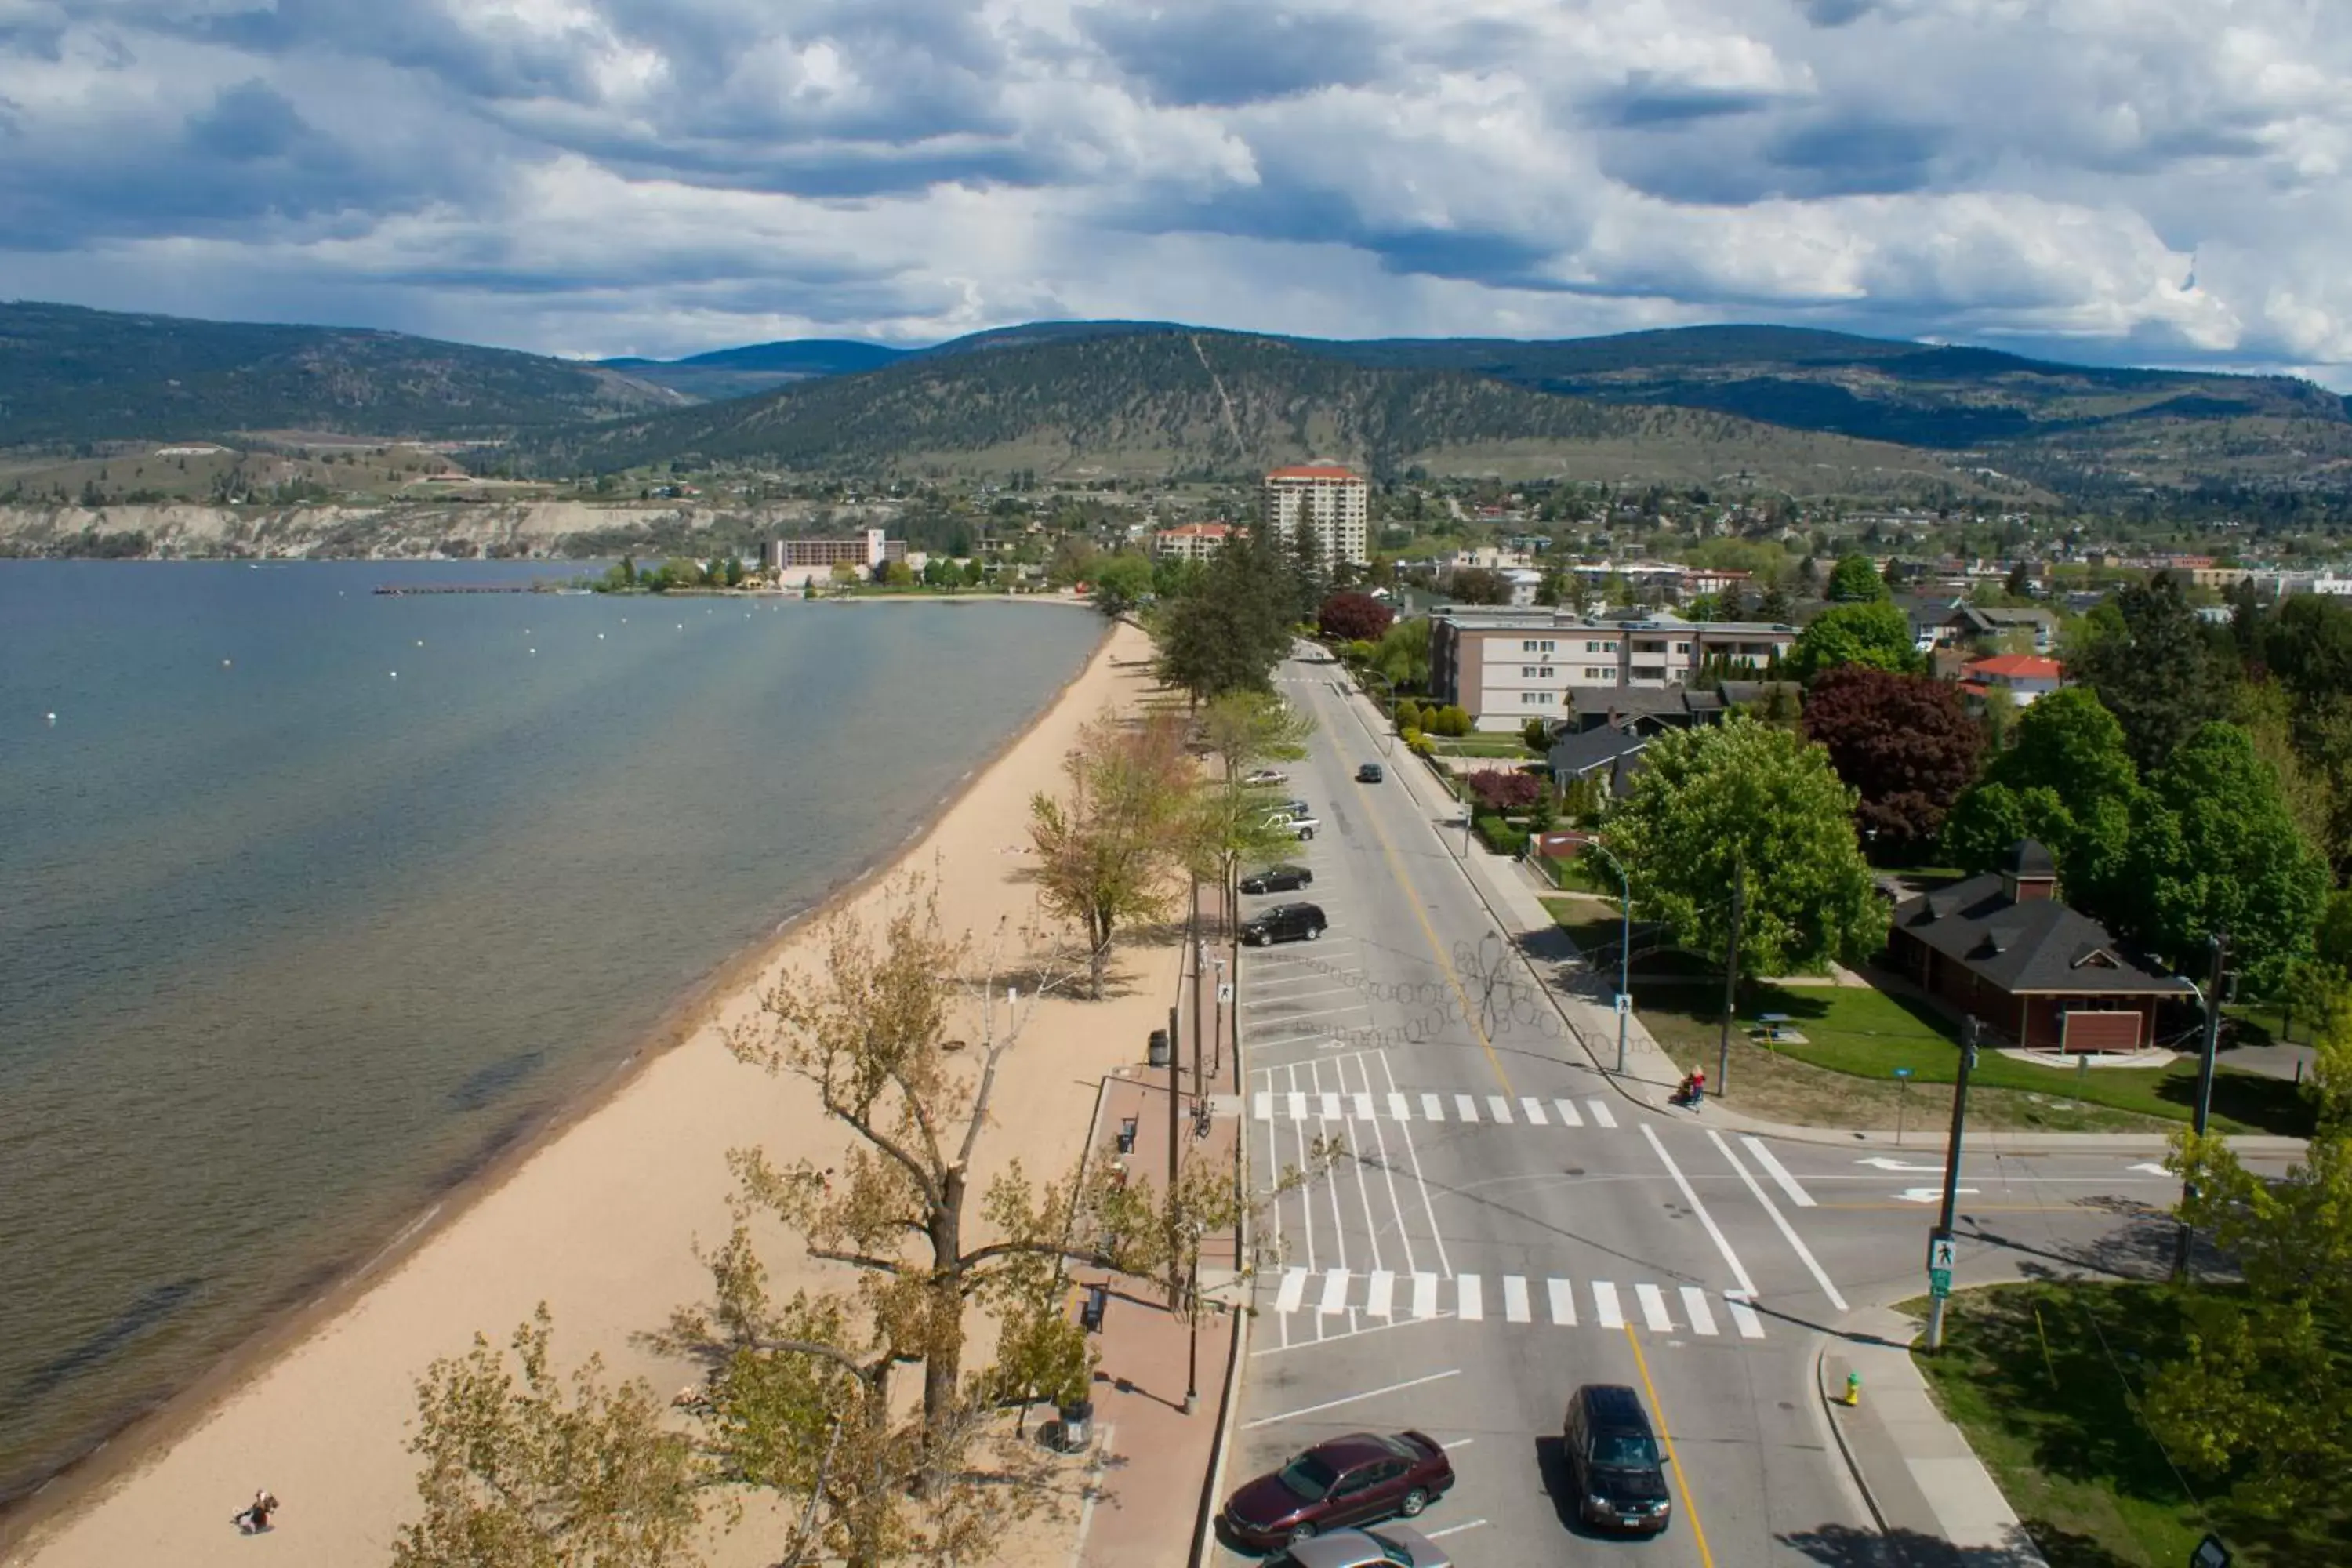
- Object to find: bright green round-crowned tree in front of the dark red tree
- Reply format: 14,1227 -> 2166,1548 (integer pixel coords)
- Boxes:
1604,717 -> 1886,973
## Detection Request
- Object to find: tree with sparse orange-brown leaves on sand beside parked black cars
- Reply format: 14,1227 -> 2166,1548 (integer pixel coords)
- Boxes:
1030,715 -> 1192,999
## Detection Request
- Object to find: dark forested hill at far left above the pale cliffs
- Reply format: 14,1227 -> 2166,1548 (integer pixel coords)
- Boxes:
0,303 -> 680,447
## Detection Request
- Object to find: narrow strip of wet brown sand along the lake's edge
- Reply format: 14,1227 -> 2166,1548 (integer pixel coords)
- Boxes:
0,611 -> 1124,1568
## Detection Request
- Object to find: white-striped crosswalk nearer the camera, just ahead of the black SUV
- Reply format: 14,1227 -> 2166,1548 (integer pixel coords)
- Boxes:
1272,1267 -> 1764,1340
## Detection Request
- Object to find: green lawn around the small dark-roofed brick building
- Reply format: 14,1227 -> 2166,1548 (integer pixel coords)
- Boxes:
1635,987 -> 2312,1135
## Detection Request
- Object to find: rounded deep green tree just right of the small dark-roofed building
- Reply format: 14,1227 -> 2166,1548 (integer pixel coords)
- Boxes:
2126,724 -> 2328,994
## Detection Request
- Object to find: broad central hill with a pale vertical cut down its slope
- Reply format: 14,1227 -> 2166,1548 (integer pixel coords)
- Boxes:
517,327 -> 2013,494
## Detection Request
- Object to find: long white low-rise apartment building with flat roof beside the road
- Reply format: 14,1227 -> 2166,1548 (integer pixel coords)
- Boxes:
1430,604 -> 1797,731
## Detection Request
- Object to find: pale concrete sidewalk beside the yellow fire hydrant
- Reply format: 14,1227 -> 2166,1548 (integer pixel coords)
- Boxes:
1816,1307 -> 2046,1568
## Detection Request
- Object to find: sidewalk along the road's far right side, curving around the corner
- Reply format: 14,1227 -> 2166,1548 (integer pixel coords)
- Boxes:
1348,689 -> 2303,1154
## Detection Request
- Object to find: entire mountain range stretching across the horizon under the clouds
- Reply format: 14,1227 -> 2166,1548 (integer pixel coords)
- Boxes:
0,303 -> 2352,501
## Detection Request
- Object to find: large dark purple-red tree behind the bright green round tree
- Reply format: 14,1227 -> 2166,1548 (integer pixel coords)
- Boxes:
1804,666 -> 1985,858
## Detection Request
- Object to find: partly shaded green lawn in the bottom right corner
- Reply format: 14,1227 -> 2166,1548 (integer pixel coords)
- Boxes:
1905,1283 -> 2345,1568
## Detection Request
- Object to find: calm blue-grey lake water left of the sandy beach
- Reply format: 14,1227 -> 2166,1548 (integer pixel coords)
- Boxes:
0,562 -> 1101,1504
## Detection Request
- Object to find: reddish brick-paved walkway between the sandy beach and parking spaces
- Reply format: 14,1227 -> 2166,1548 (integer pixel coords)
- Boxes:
1070,921 -> 1242,1568
